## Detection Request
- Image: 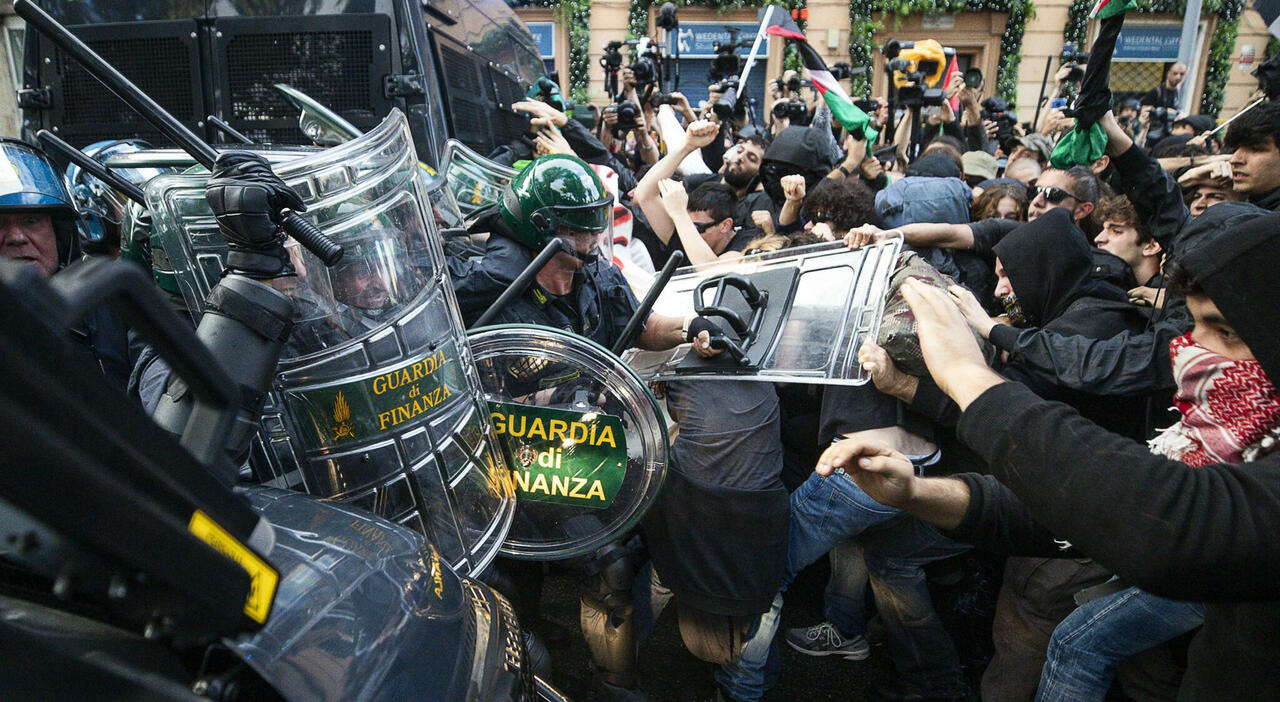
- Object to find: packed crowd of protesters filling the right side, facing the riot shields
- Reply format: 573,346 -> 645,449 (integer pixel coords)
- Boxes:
10,36 -> 1280,701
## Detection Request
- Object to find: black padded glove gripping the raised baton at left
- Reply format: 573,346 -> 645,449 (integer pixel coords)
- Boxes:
205,151 -> 307,279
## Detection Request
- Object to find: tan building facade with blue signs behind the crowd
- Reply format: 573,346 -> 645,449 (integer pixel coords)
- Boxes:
513,0 -> 1271,122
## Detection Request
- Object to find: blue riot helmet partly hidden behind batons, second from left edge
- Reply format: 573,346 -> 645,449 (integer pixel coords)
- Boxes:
65,140 -> 167,254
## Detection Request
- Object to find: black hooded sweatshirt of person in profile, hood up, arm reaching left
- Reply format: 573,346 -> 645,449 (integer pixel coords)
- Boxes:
991,208 -> 1147,438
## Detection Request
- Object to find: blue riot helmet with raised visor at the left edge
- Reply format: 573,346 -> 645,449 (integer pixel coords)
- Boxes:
0,137 -> 81,269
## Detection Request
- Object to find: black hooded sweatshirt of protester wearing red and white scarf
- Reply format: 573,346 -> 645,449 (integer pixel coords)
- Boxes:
952,214 -> 1280,701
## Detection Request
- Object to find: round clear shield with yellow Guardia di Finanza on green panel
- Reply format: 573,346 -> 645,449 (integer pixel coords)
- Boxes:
468,325 -> 667,560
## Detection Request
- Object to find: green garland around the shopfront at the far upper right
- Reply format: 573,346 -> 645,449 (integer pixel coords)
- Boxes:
1062,0 -> 1239,118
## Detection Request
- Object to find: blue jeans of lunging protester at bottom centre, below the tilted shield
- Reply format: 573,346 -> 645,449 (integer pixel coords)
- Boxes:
717,473 -> 969,701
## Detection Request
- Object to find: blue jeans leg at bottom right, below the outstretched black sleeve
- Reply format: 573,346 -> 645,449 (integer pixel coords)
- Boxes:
1036,588 -> 1204,702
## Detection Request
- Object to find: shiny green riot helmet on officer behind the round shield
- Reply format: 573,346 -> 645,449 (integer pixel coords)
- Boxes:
502,154 -> 613,251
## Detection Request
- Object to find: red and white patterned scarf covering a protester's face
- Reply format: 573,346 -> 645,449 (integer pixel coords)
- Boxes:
1149,333 -> 1280,466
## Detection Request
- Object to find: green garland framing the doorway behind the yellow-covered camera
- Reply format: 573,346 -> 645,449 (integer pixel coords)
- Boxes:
849,0 -> 1036,104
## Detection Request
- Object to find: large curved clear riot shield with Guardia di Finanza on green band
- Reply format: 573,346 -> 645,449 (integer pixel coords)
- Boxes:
146,111 -> 515,574
